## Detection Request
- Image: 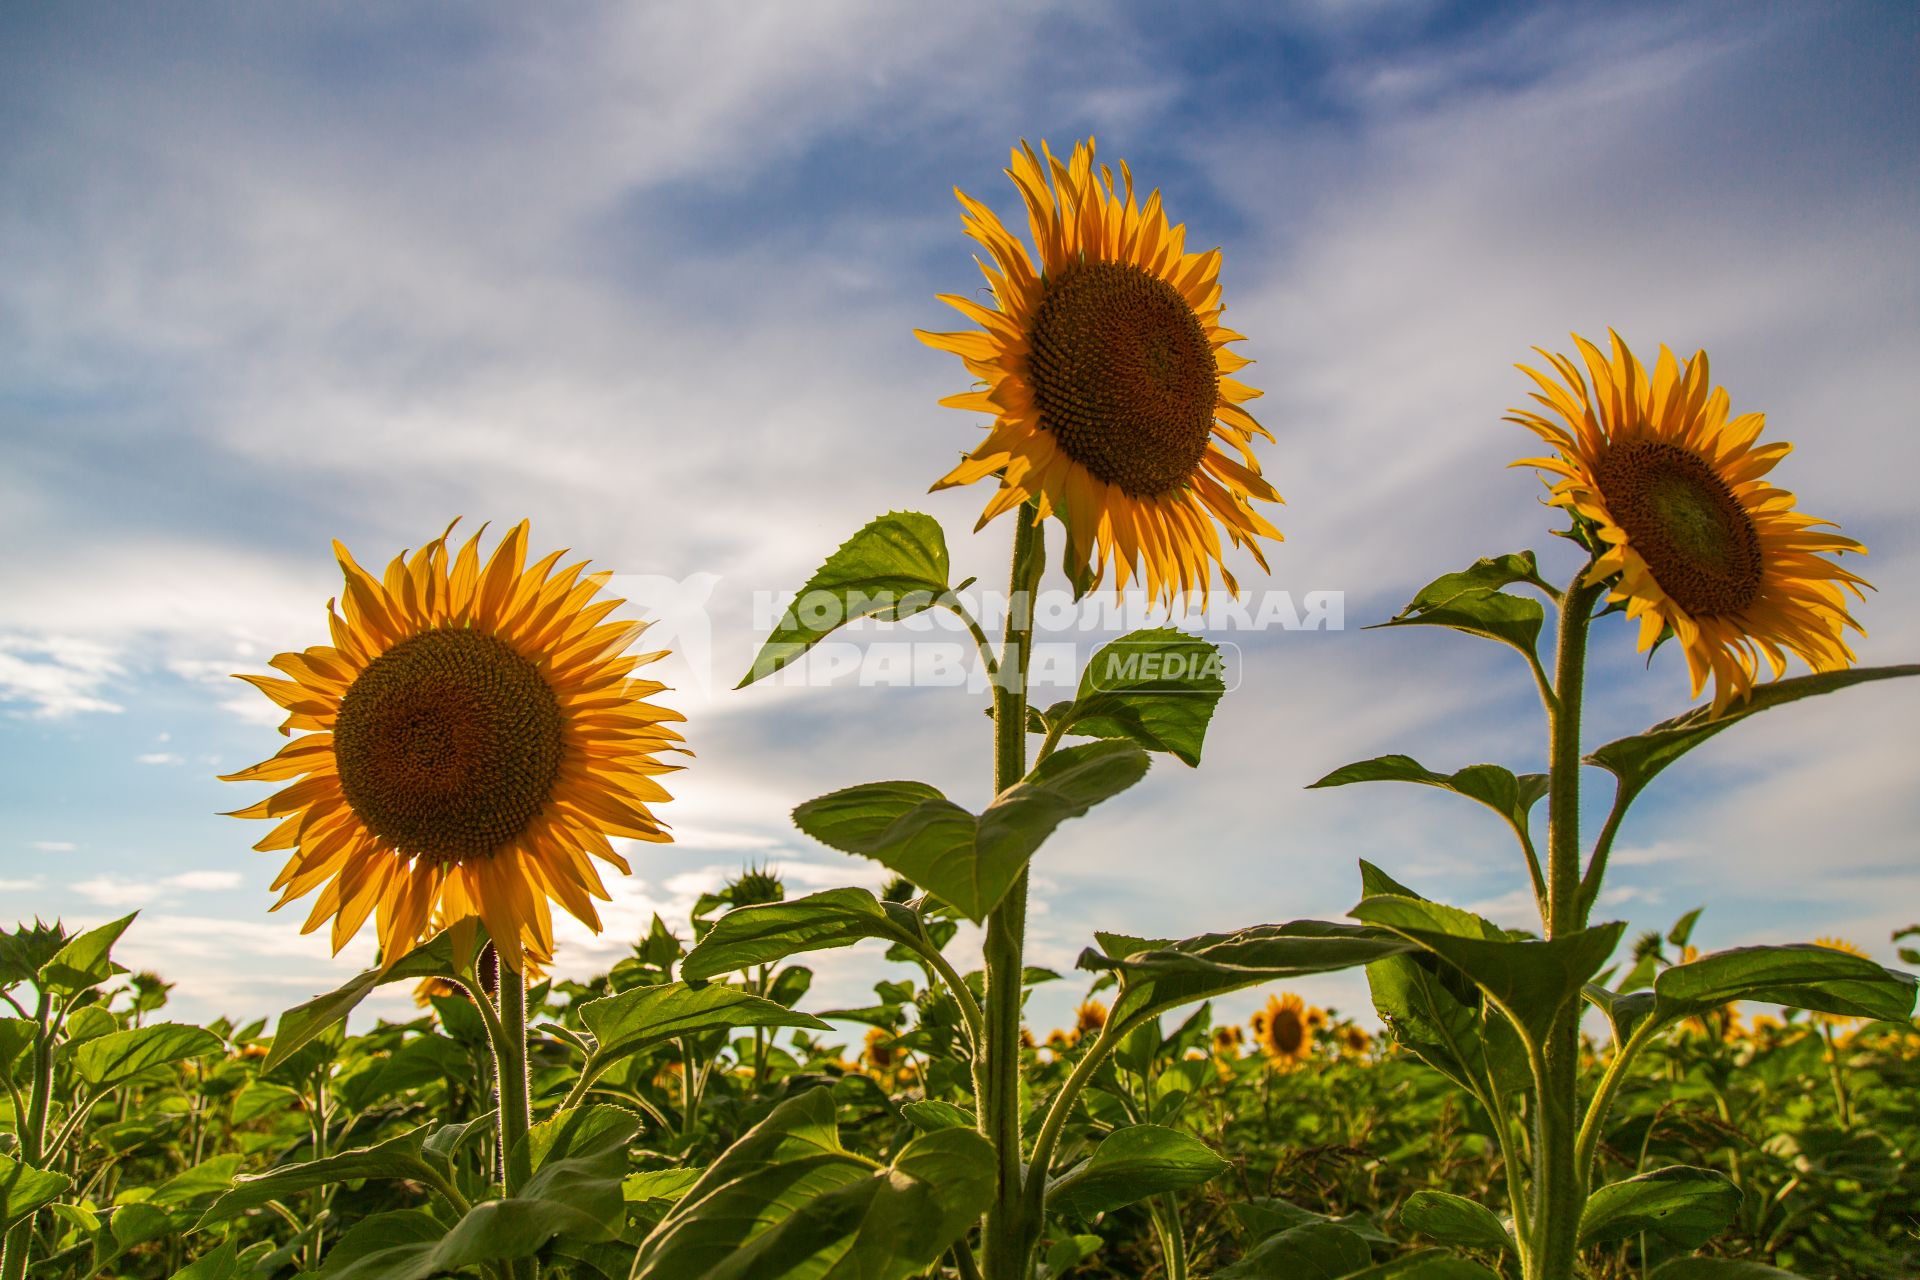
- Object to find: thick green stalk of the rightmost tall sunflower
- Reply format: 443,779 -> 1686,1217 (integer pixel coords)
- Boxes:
1526,568 -> 1601,1280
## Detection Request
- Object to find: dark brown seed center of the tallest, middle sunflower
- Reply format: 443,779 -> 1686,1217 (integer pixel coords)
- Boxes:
1027,263 -> 1219,497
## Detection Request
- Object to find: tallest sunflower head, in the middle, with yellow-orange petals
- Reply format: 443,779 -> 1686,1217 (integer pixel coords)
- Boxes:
916,138 -> 1281,601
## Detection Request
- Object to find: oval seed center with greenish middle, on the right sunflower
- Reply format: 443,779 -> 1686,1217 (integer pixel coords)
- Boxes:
1594,439 -> 1763,618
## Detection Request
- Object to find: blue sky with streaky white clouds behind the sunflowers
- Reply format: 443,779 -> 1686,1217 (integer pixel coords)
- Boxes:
0,0 -> 1920,1043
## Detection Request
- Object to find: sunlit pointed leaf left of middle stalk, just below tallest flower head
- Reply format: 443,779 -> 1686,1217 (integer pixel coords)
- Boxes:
733,510 -> 948,689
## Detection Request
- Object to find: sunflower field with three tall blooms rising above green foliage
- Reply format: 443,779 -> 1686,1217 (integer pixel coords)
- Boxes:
0,138 -> 1920,1280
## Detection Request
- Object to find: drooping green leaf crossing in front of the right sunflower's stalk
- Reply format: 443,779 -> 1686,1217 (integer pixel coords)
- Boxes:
1350,894 -> 1626,1044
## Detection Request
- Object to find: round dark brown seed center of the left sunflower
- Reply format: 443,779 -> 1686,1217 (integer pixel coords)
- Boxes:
334,628 -> 561,862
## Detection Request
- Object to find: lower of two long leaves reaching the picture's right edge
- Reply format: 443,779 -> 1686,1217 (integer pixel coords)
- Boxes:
1653,942 -> 1914,1023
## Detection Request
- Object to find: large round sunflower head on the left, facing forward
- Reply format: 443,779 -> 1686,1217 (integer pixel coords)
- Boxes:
227,520 -> 684,973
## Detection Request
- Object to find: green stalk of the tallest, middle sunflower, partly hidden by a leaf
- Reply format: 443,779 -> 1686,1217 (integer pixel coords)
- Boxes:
979,507 -> 1044,1280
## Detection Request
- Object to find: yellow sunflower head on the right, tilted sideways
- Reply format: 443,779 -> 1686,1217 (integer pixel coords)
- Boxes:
1507,334 -> 1868,716
